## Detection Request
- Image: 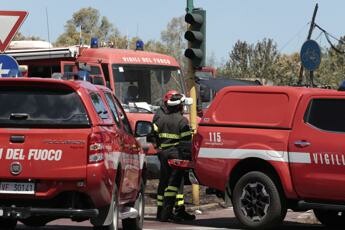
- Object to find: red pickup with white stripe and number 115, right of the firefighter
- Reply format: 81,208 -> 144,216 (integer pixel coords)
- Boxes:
172,86 -> 345,229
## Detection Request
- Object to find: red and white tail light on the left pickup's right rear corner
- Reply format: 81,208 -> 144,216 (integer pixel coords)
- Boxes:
88,133 -> 105,164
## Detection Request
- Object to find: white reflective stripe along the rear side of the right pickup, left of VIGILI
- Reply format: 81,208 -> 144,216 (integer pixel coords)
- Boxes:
198,148 -> 311,164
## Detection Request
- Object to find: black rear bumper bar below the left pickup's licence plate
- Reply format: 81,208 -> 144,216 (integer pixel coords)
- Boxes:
0,206 -> 98,219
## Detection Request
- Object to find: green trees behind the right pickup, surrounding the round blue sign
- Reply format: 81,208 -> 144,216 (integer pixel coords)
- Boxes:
217,37 -> 345,88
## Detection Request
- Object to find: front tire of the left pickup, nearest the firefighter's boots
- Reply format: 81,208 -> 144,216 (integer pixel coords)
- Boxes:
122,181 -> 145,230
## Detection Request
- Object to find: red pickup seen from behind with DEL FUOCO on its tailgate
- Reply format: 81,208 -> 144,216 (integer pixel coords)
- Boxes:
0,78 -> 149,230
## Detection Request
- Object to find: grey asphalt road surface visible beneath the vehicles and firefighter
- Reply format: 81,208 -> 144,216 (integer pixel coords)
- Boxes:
17,208 -> 326,230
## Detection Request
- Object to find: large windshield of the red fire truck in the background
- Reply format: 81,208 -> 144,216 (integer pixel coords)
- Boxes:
112,64 -> 185,112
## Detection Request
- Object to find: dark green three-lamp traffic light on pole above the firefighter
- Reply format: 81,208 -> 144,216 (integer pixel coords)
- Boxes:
184,8 -> 206,68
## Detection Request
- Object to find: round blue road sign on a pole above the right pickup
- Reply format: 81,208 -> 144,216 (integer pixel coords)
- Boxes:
300,40 -> 321,71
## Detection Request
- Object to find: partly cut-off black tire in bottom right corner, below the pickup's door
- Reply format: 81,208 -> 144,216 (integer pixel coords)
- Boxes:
313,209 -> 345,228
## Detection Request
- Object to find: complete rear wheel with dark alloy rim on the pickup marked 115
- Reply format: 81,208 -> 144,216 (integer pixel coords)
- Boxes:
232,171 -> 287,229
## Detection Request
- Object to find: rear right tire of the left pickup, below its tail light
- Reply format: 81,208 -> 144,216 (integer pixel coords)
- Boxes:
91,185 -> 119,230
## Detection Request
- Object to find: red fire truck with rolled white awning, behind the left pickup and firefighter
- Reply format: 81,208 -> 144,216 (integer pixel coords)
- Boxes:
6,44 -> 186,177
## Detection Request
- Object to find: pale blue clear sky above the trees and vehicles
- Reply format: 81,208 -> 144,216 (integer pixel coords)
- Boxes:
0,0 -> 345,63
